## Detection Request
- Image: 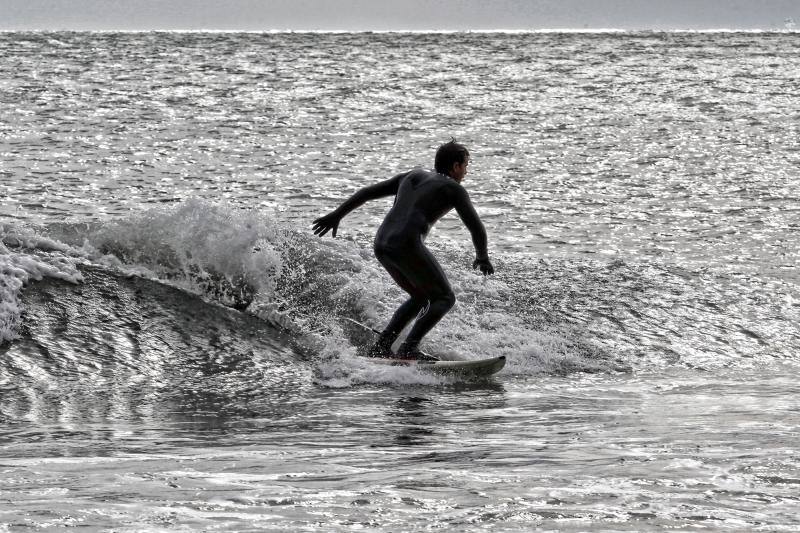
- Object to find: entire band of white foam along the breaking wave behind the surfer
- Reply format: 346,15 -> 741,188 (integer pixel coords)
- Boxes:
3,199 -> 620,378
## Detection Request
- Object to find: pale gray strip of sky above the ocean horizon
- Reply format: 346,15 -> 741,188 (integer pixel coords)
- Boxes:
0,0 -> 800,31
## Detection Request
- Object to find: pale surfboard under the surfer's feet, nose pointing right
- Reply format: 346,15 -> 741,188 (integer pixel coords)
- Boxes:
344,318 -> 506,378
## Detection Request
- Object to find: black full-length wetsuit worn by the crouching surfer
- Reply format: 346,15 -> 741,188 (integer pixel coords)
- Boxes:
328,169 -> 488,347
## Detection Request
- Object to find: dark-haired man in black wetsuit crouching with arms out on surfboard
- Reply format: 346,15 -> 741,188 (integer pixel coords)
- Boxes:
313,139 -> 494,359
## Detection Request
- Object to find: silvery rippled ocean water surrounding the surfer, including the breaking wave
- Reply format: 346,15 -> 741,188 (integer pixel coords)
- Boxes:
0,32 -> 800,532
